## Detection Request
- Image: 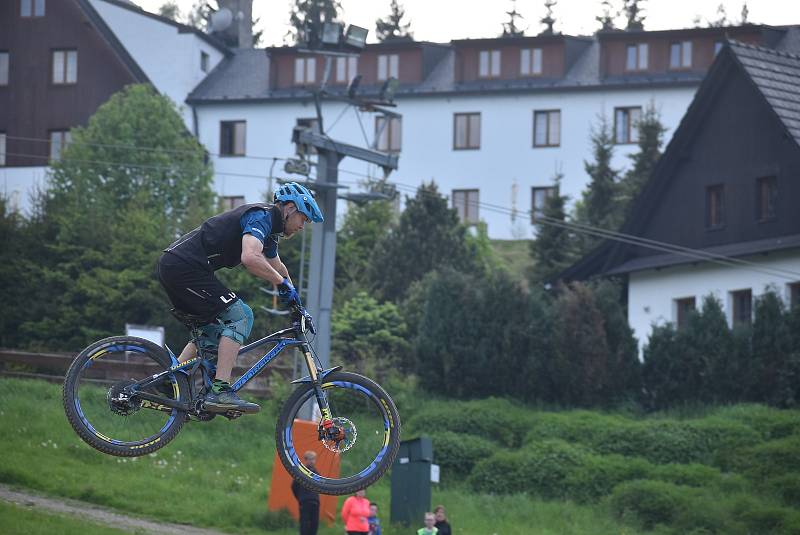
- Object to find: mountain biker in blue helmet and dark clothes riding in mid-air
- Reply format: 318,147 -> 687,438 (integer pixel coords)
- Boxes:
156,182 -> 323,413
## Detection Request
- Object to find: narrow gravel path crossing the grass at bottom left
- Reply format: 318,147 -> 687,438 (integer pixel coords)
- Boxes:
0,485 -> 233,535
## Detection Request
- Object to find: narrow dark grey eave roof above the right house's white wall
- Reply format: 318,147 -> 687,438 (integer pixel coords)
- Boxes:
606,234 -> 800,275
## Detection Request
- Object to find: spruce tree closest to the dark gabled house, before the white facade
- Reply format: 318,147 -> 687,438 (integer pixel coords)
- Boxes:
615,102 -> 666,221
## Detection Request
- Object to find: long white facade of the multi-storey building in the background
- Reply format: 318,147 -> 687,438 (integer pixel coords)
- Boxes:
197,87 -> 695,239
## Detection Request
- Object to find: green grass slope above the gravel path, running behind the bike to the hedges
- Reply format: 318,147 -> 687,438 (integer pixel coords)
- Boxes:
0,379 -> 636,535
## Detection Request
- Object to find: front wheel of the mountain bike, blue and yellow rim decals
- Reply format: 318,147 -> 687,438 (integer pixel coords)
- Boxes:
276,372 -> 400,495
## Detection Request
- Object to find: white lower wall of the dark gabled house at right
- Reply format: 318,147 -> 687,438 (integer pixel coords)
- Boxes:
628,251 -> 800,356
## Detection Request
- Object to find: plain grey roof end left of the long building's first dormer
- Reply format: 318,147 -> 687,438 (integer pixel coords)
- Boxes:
186,48 -> 270,101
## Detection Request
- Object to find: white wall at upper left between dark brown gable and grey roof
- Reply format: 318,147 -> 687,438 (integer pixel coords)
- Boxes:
90,0 -> 223,126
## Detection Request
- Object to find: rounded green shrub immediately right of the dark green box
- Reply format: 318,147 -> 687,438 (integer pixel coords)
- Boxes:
432,431 -> 498,483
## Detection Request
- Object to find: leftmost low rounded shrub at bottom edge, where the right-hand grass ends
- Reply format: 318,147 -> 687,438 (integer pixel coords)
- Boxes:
610,480 -> 692,529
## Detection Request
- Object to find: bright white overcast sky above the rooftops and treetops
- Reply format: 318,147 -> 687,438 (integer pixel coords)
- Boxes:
134,0 -> 800,46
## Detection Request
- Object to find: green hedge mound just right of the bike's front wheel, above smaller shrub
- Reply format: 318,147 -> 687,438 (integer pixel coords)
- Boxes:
408,398 -> 530,448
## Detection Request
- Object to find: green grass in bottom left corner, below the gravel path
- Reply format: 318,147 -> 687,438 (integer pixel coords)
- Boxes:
0,502 -> 142,535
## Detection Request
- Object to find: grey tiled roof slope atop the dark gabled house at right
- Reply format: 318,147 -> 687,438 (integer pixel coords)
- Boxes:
731,43 -> 800,145
